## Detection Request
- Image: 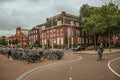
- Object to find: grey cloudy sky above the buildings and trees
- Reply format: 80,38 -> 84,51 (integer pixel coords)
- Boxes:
0,0 -> 120,36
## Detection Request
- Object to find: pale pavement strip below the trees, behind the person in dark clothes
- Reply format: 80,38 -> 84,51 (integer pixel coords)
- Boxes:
74,49 -> 120,55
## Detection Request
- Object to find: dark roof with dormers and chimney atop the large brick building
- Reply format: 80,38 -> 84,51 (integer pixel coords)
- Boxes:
36,11 -> 79,28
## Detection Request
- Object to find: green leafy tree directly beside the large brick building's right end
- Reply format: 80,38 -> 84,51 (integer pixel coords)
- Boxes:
79,4 -> 99,46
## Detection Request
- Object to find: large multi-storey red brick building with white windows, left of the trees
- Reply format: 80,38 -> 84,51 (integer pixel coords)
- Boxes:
28,11 -> 93,47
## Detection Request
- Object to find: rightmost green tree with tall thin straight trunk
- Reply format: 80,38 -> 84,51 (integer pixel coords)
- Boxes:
100,2 -> 120,51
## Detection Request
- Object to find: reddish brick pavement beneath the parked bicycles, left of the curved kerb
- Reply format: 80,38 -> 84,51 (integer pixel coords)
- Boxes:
0,52 -> 77,80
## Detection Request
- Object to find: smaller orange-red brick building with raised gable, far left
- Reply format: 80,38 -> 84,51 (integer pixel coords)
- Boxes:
8,27 -> 29,46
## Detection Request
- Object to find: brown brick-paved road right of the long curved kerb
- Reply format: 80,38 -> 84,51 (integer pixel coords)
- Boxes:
24,53 -> 120,80
